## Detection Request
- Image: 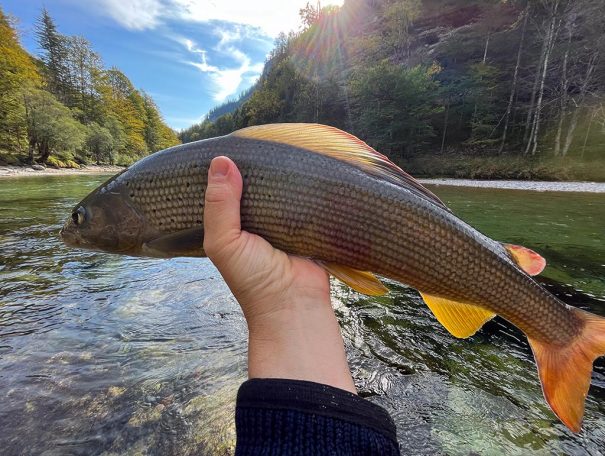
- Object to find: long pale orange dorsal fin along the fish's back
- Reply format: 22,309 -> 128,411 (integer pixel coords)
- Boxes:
232,123 -> 449,211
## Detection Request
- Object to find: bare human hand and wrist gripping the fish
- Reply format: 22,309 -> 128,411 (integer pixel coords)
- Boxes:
204,157 -> 356,393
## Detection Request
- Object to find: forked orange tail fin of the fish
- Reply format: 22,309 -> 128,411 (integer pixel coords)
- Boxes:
529,308 -> 605,432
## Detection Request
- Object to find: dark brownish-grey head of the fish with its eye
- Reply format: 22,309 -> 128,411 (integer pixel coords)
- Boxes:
61,178 -> 145,255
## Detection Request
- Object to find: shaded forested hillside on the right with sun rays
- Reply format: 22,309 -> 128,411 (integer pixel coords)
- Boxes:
180,0 -> 605,179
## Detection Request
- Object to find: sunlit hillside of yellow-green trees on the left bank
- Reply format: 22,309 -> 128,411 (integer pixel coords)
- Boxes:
0,10 -> 179,167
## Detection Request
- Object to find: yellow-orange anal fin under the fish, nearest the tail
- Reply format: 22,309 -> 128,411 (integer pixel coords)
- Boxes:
420,293 -> 496,339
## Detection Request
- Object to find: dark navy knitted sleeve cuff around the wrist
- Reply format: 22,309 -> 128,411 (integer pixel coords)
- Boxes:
235,379 -> 399,456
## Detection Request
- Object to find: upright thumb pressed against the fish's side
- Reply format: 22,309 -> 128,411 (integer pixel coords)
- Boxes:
204,157 -> 243,266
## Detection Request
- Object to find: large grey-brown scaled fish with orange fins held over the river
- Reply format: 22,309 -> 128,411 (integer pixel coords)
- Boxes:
61,124 -> 605,432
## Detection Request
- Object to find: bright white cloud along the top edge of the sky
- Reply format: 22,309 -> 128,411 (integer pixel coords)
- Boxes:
91,0 -> 343,37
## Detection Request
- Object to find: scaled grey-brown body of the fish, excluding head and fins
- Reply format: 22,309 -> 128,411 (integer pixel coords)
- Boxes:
118,138 -> 577,343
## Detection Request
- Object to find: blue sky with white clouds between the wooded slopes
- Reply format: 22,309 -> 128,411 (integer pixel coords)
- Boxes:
0,0 -> 343,130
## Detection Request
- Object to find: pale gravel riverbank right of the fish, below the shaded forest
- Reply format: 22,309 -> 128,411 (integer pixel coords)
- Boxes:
418,178 -> 605,193
